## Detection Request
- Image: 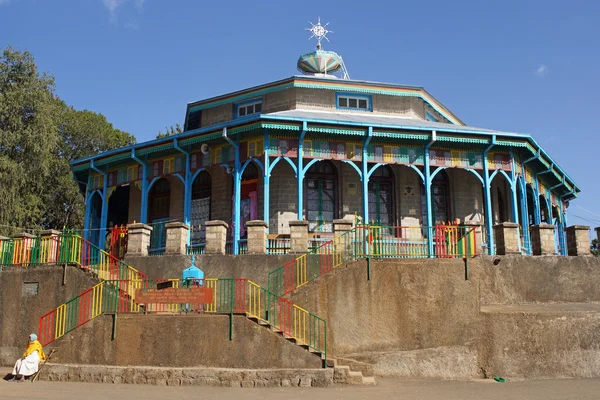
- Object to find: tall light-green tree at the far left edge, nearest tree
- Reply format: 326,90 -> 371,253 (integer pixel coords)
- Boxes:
0,47 -> 60,234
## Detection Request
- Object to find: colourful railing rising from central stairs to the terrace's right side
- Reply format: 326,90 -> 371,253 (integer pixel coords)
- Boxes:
268,225 -> 477,296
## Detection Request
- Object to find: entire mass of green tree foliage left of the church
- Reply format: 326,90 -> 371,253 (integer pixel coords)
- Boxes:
0,47 -> 135,235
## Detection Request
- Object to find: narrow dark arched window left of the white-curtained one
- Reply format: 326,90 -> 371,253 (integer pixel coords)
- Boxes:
148,178 -> 171,250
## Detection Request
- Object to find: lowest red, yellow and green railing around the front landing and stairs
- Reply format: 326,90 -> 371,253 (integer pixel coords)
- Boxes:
38,278 -> 327,360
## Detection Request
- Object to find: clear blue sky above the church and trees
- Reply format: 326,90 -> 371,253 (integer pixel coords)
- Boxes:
0,0 -> 600,230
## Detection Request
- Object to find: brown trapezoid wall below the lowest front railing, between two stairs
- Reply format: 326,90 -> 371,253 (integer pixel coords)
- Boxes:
48,314 -> 322,368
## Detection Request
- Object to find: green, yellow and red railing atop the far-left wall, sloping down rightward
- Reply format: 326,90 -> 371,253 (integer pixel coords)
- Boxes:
0,232 -> 147,279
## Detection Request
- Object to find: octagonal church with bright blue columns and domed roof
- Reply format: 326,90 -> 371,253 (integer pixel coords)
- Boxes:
71,28 -> 579,256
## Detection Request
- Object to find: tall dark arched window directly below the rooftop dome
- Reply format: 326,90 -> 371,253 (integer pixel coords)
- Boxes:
304,161 -> 337,232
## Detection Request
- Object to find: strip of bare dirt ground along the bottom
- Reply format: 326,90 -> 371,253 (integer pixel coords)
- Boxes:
0,378 -> 600,400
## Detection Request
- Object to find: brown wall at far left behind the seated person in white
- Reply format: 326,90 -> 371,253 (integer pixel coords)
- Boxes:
0,266 -> 98,365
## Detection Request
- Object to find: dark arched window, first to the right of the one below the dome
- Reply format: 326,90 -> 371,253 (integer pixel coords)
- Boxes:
369,165 -> 394,226
